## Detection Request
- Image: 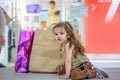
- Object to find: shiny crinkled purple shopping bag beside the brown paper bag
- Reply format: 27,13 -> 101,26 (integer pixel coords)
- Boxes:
15,30 -> 34,73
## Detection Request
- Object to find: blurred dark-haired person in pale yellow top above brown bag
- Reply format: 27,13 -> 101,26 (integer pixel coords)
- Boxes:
46,1 -> 60,28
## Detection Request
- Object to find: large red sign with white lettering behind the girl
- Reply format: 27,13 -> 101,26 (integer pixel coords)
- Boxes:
84,0 -> 120,54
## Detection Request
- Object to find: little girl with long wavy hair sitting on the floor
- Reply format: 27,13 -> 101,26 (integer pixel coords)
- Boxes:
52,22 -> 108,80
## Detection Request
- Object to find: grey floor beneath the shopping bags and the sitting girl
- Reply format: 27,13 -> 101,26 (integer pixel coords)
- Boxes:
0,68 -> 120,80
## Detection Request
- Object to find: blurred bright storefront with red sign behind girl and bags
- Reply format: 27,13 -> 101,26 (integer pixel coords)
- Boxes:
0,0 -> 120,68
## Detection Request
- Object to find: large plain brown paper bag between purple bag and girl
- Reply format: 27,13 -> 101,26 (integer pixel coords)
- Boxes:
29,29 -> 60,72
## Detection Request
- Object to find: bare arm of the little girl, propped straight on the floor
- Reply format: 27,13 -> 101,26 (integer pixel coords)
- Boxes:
59,43 -> 74,78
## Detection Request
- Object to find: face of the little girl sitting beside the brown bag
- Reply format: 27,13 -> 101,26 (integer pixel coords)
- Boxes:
54,27 -> 67,44
